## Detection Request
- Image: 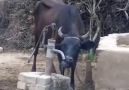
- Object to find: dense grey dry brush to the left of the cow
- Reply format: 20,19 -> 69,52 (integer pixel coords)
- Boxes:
0,0 -> 35,49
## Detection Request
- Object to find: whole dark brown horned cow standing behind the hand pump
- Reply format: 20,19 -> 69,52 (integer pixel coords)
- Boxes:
32,0 -> 94,88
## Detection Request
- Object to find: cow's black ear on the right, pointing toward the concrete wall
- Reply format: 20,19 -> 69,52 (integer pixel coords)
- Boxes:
81,40 -> 95,50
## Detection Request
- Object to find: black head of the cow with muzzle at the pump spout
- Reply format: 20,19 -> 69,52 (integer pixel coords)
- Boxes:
56,28 -> 95,68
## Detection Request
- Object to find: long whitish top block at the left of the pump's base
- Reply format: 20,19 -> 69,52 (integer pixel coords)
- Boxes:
18,72 -> 43,84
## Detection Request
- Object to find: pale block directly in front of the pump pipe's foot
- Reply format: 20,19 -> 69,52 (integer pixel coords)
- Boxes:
36,75 -> 52,86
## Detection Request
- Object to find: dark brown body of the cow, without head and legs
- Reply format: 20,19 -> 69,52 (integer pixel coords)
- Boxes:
34,0 -> 84,43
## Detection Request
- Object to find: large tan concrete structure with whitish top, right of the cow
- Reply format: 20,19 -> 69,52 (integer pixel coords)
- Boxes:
93,33 -> 129,90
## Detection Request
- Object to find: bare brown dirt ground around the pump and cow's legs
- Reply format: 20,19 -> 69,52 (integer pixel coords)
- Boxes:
0,52 -> 91,90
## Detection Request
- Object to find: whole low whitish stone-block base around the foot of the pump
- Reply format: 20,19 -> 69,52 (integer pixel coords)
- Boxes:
17,72 -> 71,90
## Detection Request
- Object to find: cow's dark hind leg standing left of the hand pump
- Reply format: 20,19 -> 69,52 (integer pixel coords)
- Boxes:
31,36 -> 39,72
